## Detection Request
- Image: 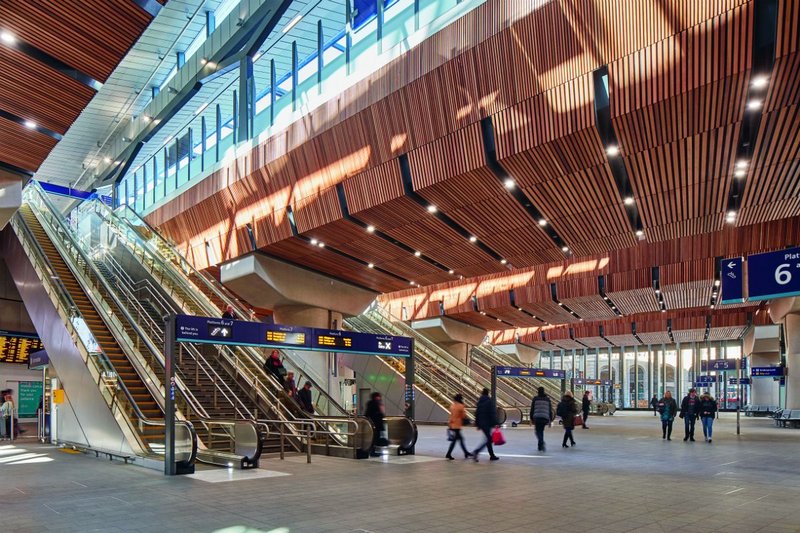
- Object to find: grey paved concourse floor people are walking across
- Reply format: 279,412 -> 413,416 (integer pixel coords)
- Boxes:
0,412 -> 800,533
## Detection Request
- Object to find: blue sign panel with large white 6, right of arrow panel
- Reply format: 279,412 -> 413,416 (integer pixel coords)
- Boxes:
747,248 -> 800,301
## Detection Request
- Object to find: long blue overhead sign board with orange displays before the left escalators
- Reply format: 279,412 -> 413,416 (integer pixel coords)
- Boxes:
175,315 -> 413,357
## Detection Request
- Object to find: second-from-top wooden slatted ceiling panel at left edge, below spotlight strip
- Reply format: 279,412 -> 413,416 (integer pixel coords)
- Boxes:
0,46 -> 94,133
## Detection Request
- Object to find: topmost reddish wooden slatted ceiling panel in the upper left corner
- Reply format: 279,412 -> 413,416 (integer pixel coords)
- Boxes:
0,0 -> 151,82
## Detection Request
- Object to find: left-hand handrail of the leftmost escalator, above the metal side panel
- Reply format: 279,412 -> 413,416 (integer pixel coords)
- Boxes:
14,206 -> 197,455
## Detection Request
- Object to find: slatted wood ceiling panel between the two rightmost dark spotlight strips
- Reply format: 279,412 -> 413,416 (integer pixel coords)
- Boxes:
609,5 -> 752,241
